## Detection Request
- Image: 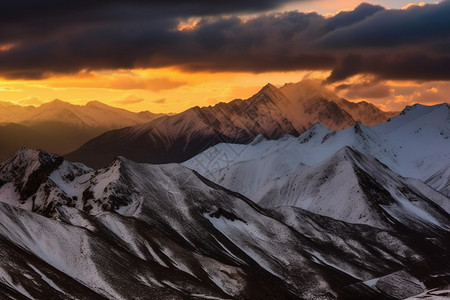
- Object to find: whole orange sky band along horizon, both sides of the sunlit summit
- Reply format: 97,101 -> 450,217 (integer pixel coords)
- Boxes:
0,68 -> 450,113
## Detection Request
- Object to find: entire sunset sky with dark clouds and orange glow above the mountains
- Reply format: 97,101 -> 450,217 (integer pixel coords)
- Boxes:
0,0 -> 450,112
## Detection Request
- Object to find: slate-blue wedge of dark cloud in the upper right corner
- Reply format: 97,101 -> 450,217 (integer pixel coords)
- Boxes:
317,1 -> 450,50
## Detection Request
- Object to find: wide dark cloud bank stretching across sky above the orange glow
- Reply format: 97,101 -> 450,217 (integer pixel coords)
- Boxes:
0,0 -> 450,82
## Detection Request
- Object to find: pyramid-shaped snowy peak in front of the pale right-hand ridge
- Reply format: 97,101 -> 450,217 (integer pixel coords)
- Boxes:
252,147 -> 450,230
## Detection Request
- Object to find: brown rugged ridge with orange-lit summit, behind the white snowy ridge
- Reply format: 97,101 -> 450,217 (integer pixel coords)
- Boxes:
65,80 -> 393,167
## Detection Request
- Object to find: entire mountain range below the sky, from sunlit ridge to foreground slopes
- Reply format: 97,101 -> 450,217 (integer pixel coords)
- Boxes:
0,80 -> 450,299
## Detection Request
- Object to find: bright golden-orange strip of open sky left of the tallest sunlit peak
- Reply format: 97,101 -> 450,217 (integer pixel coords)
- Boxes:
0,68 -> 329,113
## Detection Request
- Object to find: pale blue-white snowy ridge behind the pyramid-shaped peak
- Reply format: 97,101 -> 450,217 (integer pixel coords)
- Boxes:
183,104 -> 450,196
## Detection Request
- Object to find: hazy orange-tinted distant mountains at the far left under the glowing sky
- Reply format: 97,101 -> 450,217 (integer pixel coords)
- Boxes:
0,100 -> 162,160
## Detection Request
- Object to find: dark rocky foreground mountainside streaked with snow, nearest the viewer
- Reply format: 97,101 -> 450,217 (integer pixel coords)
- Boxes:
0,149 -> 450,299
